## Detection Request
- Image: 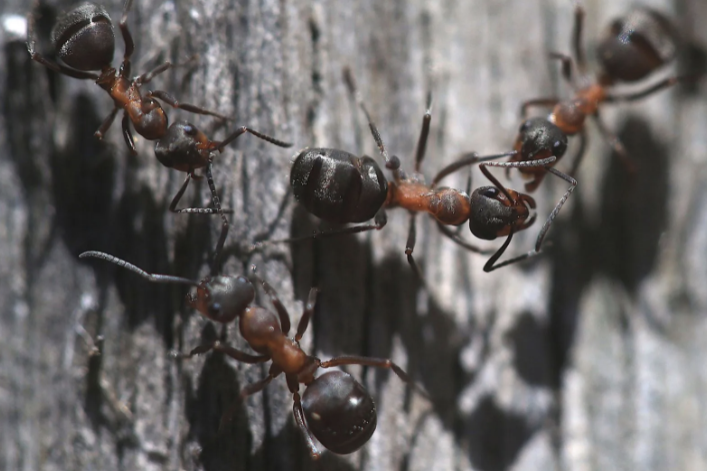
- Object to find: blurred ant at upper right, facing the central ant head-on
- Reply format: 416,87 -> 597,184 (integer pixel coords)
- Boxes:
511,5 -> 687,183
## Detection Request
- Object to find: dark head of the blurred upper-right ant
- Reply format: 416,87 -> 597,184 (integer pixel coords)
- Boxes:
515,117 -> 567,160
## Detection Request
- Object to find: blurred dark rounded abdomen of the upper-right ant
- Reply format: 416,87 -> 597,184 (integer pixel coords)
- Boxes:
597,8 -> 677,82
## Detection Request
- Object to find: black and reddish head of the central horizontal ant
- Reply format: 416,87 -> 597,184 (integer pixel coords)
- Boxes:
469,186 -> 535,240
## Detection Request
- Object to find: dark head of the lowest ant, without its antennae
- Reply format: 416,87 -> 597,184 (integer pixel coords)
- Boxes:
190,276 -> 255,324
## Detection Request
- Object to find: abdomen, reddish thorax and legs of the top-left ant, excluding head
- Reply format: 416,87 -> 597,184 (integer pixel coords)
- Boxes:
27,0 -> 228,154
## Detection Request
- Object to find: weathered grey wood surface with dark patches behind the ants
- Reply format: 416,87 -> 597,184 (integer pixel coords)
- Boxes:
0,0 -> 707,471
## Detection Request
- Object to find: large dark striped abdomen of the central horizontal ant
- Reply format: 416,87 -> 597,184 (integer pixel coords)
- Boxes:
290,148 -> 388,223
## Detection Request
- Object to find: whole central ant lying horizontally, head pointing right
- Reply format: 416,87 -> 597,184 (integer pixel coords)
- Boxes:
287,68 -> 576,276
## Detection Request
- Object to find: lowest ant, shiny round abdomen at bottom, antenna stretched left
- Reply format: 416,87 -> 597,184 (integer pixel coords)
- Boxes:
79,251 -> 429,459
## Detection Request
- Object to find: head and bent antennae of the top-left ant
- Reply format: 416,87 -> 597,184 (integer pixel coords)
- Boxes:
155,120 -> 292,274
